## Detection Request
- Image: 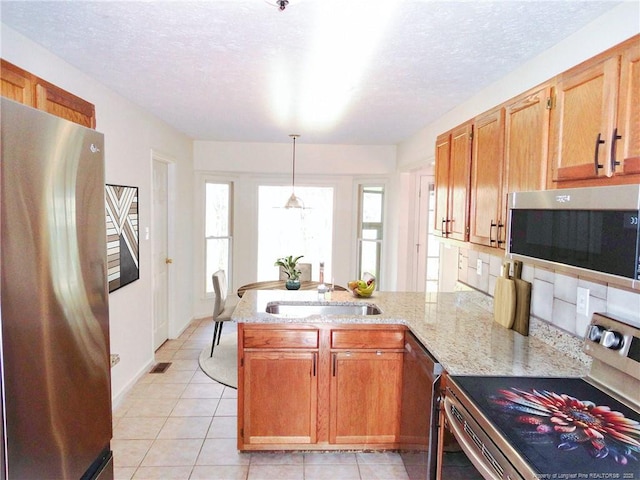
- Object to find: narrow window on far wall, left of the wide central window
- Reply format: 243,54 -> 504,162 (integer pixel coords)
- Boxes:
204,181 -> 233,295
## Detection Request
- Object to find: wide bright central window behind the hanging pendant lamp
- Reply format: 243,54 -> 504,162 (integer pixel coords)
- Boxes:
257,185 -> 333,281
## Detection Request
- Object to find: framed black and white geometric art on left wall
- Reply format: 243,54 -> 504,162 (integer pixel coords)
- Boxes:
105,185 -> 140,293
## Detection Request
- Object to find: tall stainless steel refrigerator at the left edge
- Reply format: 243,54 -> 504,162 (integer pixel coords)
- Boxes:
0,98 -> 113,480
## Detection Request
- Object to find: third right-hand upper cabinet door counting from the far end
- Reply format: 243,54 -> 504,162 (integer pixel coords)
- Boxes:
469,108 -> 504,247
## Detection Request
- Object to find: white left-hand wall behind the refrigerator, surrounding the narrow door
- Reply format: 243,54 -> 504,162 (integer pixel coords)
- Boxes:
1,24 -> 193,401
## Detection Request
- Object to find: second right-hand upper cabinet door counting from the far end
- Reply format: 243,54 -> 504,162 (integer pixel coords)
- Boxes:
448,123 -> 473,242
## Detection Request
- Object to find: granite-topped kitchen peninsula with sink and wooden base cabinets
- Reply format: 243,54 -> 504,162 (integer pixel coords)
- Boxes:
232,290 -> 589,451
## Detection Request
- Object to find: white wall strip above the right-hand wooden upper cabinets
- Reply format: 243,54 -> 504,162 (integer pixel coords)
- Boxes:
398,0 -> 640,170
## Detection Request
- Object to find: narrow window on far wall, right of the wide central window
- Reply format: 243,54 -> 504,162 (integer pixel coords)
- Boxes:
357,185 -> 384,283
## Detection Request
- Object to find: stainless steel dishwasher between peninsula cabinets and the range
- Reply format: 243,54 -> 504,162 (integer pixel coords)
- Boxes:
400,332 -> 442,480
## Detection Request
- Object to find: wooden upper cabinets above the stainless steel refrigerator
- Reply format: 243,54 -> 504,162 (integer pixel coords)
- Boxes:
0,60 -> 96,128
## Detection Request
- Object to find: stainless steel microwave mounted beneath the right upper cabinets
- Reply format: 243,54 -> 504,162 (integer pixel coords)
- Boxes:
507,185 -> 640,290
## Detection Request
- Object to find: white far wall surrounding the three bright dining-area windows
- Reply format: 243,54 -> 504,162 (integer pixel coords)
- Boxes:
193,140 -> 398,317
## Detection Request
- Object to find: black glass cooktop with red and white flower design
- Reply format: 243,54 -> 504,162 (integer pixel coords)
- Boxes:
453,376 -> 640,480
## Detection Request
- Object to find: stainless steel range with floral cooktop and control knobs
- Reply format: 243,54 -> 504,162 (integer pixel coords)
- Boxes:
441,313 -> 640,480
